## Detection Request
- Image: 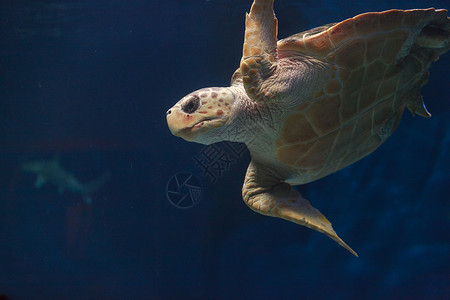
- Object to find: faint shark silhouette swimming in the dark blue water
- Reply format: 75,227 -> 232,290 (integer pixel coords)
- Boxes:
22,155 -> 110,204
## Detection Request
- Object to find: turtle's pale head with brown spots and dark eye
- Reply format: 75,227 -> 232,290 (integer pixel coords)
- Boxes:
167,88 -> 235,145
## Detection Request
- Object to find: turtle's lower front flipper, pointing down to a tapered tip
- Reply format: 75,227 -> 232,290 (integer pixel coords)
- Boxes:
242,161 -> 358,256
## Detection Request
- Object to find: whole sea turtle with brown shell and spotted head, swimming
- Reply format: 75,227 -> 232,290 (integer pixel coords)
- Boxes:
167,0 -> 450,256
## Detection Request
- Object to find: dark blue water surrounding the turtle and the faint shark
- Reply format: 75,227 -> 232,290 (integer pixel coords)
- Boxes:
0,0 -> 450,299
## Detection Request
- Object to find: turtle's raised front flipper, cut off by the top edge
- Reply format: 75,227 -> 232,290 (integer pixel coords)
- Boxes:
240,0 -> 278,102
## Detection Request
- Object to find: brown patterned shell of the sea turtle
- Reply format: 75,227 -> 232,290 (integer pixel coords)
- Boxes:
276,9 -> 450,180
